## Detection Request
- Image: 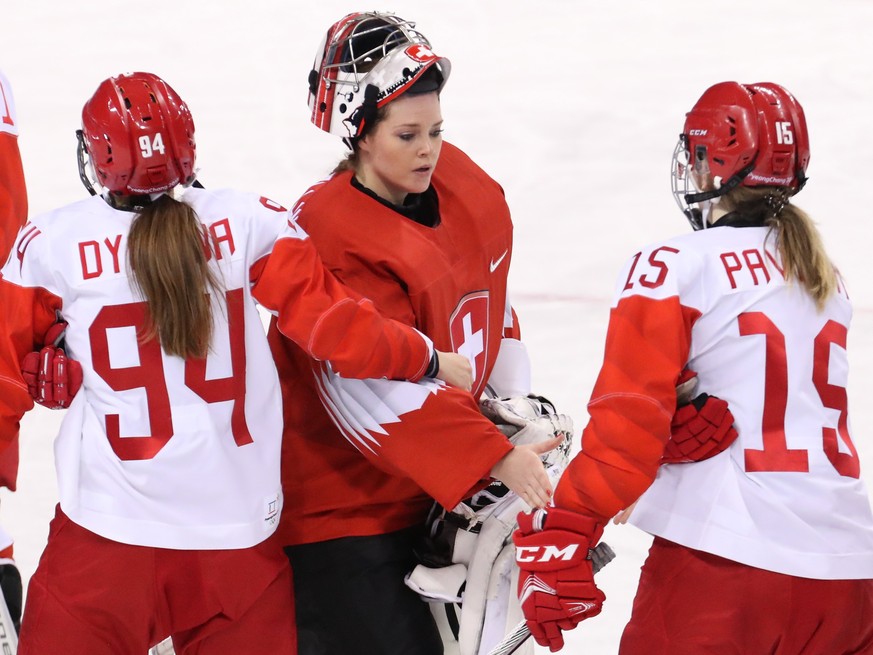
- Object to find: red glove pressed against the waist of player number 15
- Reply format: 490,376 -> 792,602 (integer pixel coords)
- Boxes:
661,369 -> 737,464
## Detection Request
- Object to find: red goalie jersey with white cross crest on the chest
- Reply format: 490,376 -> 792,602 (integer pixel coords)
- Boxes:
270,143 -> 512,544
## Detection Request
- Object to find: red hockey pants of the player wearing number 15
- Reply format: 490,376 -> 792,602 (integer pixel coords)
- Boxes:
619,537 -> 873,655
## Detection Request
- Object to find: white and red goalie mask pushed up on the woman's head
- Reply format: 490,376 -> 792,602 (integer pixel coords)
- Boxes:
309,12 -> 451,139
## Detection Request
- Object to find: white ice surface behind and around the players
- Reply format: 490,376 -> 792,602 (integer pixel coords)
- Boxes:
0,0 -> 873,655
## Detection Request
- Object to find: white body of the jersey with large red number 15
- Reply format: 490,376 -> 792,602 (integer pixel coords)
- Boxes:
619,227 -> 873,579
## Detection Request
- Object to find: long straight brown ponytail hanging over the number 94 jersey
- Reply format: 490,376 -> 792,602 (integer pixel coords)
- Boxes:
127,194 -> 221,358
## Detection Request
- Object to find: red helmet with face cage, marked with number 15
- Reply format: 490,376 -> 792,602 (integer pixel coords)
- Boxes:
672,82 -> 809,230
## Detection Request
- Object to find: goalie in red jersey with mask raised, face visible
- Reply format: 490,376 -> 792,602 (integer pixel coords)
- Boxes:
270,12 -> 730,655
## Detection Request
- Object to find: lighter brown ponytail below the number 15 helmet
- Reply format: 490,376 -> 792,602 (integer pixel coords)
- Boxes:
724,187 -> 837,309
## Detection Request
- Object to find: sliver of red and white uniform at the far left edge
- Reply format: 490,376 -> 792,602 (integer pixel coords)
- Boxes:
0,71 -> 27,504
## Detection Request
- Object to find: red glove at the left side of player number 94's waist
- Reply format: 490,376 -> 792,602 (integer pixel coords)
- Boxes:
21,322 -> 82,409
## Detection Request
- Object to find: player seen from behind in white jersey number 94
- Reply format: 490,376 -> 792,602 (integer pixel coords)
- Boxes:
0,73 -> 471,655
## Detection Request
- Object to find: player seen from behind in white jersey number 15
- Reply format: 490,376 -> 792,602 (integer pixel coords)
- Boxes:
515,82 -> 873,655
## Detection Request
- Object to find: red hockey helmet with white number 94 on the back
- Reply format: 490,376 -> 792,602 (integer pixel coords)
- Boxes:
77,73 -> 196,196
